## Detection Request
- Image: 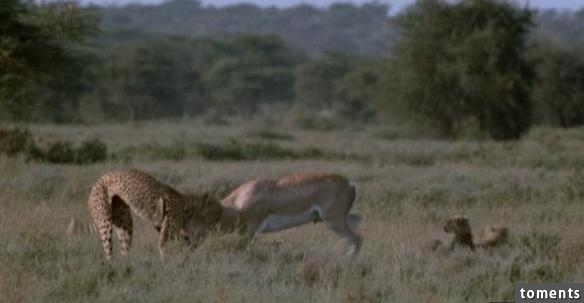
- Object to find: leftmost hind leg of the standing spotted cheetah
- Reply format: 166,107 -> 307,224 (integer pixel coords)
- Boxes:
88,184 -> 112,261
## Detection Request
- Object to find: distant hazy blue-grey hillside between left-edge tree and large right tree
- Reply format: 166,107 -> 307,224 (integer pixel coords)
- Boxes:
101,0 -> 390,54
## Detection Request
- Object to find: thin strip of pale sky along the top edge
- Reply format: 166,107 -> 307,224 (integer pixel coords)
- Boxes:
86,0 -> 584,12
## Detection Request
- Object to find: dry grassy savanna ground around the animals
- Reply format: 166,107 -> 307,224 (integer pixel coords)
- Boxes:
0,122 -> 584,302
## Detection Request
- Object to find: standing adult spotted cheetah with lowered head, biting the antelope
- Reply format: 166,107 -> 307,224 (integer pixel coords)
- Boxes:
88,169 -> 216,261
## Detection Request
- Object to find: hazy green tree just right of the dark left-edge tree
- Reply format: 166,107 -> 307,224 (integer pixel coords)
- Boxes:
101,38 -> 206,120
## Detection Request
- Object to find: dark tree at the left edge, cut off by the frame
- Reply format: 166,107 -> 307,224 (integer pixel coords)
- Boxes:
0,0 -> 97,121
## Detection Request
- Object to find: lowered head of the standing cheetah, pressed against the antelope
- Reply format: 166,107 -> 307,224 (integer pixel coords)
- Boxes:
181,191 -> 223,242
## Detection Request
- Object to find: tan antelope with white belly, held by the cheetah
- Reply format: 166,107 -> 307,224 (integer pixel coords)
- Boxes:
212,173 -> 362,254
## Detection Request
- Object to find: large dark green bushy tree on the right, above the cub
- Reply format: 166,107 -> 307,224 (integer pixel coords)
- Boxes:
383,0 -> 533,140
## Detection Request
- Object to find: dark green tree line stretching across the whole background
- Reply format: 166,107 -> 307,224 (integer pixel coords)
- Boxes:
0,0 -> 584,140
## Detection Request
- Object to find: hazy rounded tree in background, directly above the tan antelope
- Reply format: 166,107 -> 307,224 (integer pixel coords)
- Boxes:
206,35 -> 301,115
